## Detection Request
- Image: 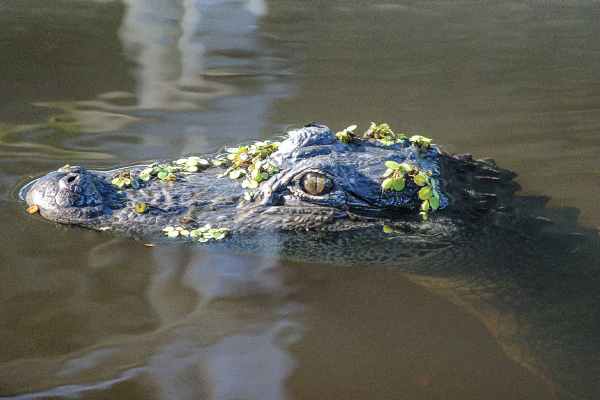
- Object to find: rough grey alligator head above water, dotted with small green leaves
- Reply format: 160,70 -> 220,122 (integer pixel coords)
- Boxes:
25,124 -> 510,241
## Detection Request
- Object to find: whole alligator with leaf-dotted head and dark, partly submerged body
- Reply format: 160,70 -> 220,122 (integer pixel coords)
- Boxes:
19,123 -> 600,398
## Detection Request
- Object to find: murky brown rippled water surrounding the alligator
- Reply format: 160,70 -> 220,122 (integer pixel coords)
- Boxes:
0,0 -> 600,399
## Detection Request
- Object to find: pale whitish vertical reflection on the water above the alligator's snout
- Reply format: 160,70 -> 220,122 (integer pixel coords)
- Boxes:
119,0 -> 266,109
